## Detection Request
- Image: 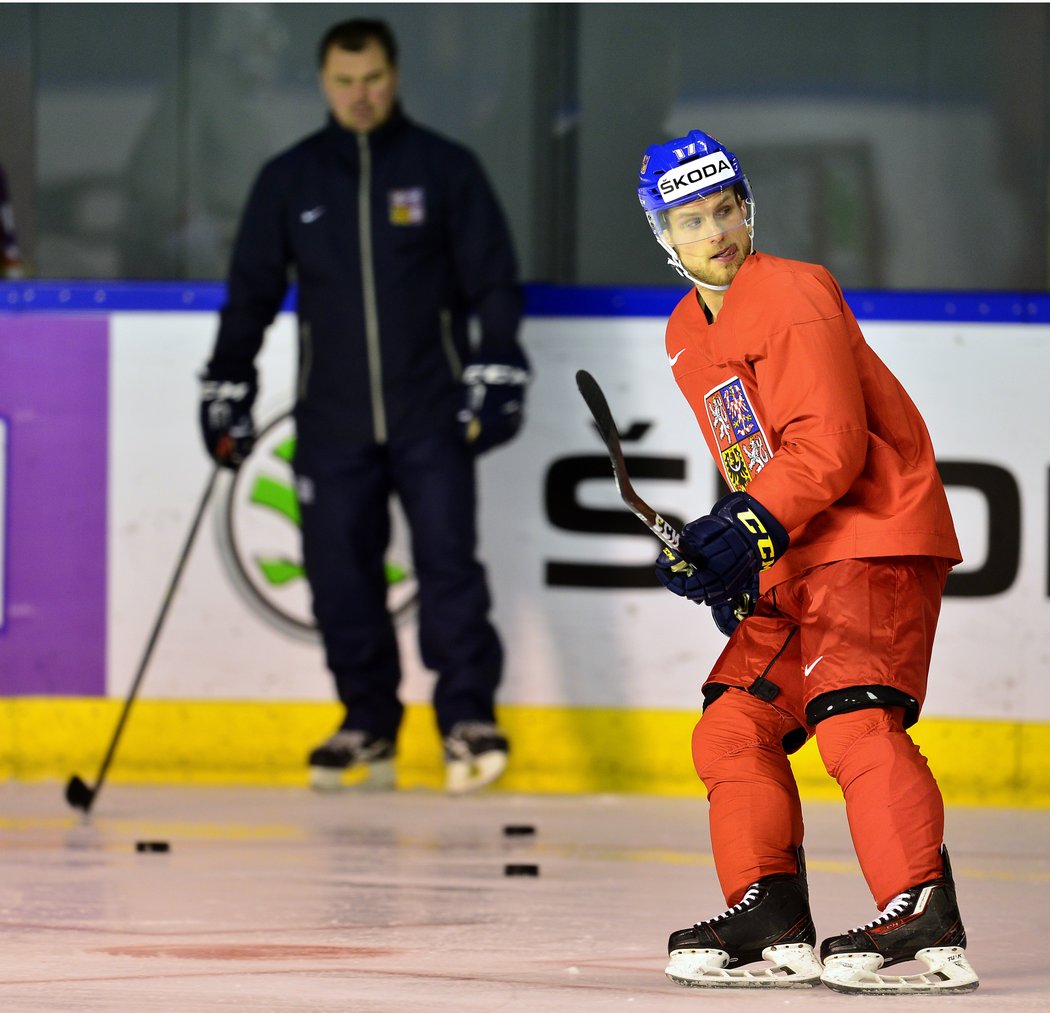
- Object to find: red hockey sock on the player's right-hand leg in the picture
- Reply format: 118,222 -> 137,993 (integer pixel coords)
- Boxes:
817,708 -> 944,909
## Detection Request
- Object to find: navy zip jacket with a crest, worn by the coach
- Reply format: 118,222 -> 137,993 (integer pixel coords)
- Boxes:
208,109 -> 524,445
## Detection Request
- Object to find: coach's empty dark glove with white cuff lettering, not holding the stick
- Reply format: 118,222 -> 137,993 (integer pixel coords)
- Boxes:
456,354 -> 532,453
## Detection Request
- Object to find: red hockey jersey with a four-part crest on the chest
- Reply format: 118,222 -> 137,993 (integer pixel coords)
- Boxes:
667,253 -> 962,591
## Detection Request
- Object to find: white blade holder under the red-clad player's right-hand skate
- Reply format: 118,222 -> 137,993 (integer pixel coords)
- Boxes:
820,946 -> 980,995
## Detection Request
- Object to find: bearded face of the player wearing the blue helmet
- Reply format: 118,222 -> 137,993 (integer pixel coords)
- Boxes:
664,189 -> 751,286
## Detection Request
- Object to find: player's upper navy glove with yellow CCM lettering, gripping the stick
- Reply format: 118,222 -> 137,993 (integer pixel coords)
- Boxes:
656,492 -> 791,606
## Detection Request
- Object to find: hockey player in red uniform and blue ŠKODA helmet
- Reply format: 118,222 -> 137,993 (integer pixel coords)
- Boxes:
638,130 -> 978,994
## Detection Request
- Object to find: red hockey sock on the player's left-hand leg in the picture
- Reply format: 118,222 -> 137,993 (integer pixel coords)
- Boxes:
693,690 -> 802,905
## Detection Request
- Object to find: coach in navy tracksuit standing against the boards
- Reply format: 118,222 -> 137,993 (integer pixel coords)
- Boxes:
202,15 -> 528,792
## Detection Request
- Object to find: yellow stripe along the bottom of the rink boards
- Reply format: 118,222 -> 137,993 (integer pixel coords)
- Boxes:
0,697 -> 1050,806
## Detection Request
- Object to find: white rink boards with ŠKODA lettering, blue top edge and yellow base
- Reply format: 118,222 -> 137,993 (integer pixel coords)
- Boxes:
0,282 -> 1050,804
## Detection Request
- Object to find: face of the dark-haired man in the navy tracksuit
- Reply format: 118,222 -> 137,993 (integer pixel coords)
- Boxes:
321,41 -> 397,133
